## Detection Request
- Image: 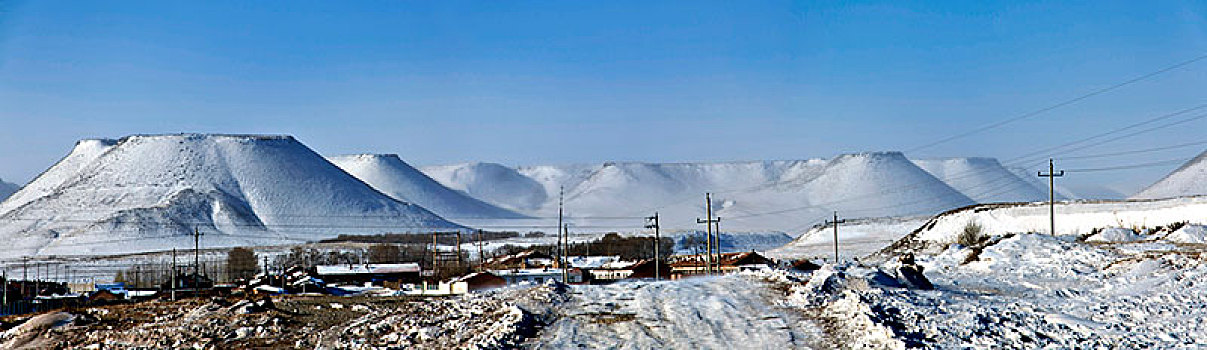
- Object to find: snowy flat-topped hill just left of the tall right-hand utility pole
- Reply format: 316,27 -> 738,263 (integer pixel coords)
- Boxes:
912,158 -> 1048,203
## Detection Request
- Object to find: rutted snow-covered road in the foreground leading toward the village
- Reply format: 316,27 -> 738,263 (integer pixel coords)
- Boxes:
532,275 -> 822,349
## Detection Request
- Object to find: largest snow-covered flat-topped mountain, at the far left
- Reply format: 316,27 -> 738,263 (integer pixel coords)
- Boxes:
0,134 -> 460,257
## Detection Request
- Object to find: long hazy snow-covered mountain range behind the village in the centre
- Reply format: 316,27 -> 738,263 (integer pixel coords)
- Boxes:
422,152 -> 975,233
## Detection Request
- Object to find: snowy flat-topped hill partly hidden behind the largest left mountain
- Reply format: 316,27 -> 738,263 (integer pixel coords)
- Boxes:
327,154 -> 525,218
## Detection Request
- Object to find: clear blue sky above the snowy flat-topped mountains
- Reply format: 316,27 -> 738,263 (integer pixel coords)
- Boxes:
0,0 -> 1207,194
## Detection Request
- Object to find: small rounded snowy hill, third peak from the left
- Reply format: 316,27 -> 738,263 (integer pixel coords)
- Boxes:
421,163 -> 545,214
